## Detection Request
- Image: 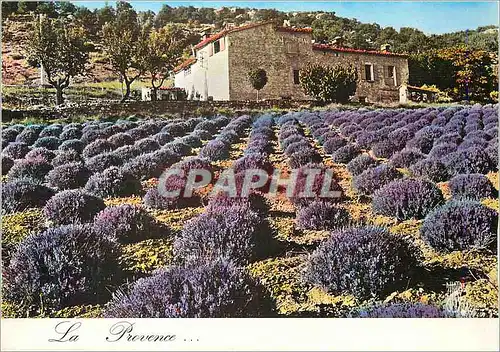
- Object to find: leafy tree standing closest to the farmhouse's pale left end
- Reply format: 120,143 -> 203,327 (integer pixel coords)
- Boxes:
144,24 -> 187,101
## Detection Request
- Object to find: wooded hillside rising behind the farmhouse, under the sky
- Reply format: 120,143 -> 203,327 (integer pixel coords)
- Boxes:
2,1 -> 498,105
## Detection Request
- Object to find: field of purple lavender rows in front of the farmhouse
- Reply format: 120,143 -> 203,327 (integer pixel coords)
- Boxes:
2,104 -> 498,318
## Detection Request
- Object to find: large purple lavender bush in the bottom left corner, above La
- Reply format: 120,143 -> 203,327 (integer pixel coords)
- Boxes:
3,225 -> 120,315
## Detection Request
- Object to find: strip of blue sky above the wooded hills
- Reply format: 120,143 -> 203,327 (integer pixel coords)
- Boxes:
72,0 -> 499,34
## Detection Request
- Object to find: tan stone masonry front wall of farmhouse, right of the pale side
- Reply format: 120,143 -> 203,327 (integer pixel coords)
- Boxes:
228,24 -> 409,102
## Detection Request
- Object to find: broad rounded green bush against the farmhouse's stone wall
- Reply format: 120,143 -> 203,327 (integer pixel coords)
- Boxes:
299,64 -> 358,104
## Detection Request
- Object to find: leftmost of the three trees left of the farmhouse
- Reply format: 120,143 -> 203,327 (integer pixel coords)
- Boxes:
27,17 -> 90,105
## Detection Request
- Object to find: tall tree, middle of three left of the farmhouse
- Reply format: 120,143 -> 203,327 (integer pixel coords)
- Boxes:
102,2 -> 150,102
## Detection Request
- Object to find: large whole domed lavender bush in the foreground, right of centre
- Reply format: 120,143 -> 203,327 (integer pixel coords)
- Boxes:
305,227 -> 419,299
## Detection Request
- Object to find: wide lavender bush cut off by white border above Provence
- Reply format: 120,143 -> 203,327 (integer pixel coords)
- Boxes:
104,260 -> 271,318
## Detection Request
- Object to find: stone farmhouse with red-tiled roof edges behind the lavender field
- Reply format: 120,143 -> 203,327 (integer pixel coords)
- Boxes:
174,22 -> 408,102
